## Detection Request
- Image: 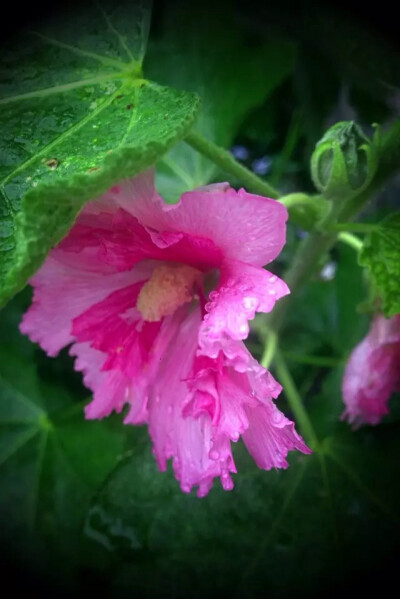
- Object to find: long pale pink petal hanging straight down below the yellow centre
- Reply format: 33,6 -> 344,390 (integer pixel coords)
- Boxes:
148,309 -> 236,496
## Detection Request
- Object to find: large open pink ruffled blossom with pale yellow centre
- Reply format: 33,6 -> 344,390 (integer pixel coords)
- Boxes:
21,171 -> 309,496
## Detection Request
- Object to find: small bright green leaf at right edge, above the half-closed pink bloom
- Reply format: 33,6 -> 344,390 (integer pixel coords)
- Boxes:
359,212 -> 400,318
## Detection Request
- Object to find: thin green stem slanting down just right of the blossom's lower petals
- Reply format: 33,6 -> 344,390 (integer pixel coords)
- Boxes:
275,349 -> 319,450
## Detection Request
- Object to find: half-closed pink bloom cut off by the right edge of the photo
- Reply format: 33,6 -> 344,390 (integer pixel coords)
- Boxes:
342,314 -> 400,427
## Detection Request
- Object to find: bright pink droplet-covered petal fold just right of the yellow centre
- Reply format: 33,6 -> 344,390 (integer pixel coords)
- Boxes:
199,261 -> 289,357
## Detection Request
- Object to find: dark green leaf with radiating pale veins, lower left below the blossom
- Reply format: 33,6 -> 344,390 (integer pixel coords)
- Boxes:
0,312 -> 124,579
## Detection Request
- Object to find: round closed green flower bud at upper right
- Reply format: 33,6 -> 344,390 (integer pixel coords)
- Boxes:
311,121 -> 378,200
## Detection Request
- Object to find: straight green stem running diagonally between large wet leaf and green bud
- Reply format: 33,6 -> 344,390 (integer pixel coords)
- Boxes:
185,129 -> 280,199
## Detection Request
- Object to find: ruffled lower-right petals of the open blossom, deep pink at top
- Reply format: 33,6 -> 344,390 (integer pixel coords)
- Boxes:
185,342 -> 311,470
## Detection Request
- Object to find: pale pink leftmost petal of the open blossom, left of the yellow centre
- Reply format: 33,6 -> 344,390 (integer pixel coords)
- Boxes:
20,250 -> 146,356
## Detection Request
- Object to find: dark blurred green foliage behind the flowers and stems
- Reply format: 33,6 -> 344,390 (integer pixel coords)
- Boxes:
0,2 -> 400,598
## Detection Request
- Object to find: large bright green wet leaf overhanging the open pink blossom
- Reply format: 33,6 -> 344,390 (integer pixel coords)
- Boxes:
0,3 -> 198,304
